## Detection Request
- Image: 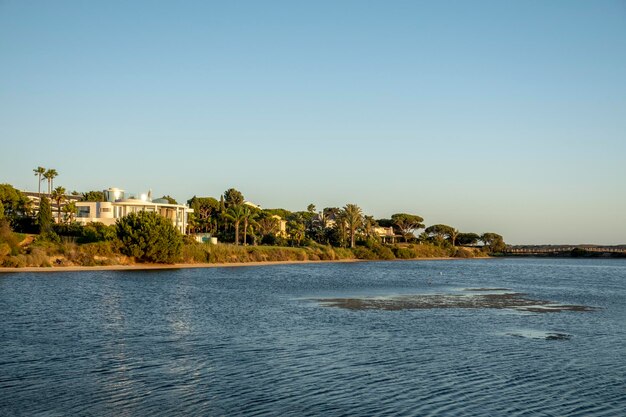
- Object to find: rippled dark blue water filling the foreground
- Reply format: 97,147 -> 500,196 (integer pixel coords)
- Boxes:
0,259 -> 626,416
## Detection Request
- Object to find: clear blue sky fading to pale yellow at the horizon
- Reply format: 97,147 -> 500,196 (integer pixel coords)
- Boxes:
0,0 -> 626,244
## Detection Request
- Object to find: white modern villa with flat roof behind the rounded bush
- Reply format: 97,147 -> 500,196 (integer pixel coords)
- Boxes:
76,188 -> 193,234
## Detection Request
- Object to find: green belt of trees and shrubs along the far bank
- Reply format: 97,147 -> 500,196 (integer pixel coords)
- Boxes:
0,171 -> 506,266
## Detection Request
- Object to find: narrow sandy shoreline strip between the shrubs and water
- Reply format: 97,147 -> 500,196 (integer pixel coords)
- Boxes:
0,257 -> 472,275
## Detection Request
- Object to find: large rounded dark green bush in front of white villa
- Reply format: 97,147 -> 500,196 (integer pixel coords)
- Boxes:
115,211 -> 183,263
